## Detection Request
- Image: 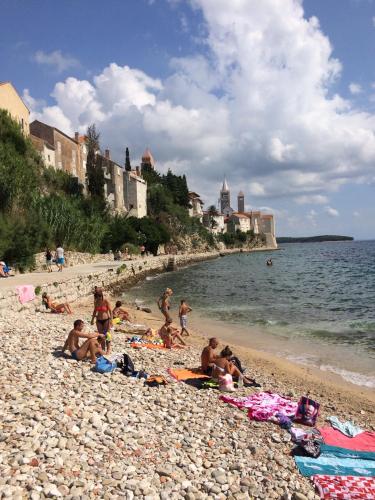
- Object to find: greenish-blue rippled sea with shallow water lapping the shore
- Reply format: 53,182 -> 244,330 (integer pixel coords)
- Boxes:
125,241 -> 375,388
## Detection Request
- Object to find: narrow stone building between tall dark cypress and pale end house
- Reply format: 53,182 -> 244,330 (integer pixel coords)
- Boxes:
96,149 -> 125,213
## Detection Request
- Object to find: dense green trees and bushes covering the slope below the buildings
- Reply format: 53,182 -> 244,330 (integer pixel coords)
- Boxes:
0,110 -> 214,270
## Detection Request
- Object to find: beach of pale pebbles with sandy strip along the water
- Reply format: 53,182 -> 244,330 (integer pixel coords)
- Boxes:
0,292 -> 375,500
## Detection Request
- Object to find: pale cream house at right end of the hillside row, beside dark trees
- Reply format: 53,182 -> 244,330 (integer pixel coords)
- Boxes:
123,167 -> 147,219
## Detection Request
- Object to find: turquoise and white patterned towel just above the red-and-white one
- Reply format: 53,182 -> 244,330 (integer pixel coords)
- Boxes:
294,453 -> 375,477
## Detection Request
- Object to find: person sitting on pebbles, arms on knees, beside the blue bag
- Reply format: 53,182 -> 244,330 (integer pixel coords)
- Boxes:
62,319 -> 104,364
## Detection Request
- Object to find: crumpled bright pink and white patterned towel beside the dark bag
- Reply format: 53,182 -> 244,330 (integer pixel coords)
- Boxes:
220,392 -> 298,422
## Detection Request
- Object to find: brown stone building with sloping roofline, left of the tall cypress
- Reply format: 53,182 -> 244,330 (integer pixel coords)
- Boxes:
30,120 -> 86,185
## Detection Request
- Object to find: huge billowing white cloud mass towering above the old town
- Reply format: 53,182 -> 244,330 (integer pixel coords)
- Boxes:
25,0 -> 375,207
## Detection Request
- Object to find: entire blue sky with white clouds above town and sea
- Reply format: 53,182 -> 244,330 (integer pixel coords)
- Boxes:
0,0 -> 375,239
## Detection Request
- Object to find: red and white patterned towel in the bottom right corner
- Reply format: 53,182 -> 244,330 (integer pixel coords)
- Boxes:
311,474 -> 375,500
